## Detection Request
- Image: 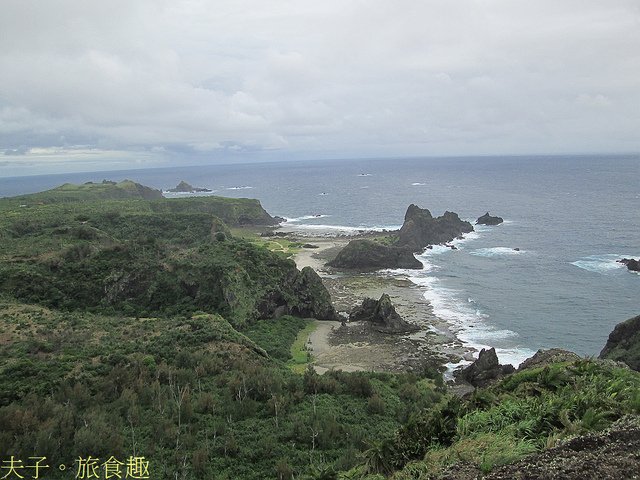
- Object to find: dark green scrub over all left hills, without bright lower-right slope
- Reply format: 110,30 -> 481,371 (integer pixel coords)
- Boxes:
0,184 -> 441,479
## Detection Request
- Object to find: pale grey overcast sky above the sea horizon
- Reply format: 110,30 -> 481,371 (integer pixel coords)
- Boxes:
0,0 -> 640,176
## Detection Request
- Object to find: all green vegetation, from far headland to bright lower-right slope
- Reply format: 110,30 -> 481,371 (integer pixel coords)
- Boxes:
0,182 -> 640,480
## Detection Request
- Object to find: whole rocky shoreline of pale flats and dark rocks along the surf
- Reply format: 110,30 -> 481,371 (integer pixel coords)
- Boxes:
282,205 -> 640,394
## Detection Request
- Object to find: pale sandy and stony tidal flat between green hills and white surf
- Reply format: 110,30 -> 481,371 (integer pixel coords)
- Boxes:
294,237 -> 468,373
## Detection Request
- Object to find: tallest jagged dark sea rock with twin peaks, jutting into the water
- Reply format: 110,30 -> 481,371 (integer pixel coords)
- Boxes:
396,204 -> 473,252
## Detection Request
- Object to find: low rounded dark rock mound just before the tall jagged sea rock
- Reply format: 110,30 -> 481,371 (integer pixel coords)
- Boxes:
327,240 -> 422,270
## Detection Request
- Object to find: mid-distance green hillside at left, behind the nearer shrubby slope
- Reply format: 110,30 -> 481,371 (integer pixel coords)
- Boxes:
0,184 -> 328,325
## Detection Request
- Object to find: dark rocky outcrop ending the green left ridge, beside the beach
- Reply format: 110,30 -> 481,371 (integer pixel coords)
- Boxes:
257,267 -> 338,320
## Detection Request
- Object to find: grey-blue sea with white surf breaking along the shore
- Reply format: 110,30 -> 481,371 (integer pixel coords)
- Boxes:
0,155 -> 640,363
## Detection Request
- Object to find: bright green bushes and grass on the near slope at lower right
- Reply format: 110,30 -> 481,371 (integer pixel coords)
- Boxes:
356,360 -> 640,480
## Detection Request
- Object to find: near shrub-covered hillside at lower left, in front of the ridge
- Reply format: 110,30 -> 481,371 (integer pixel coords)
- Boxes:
0,299 -> 441,479
